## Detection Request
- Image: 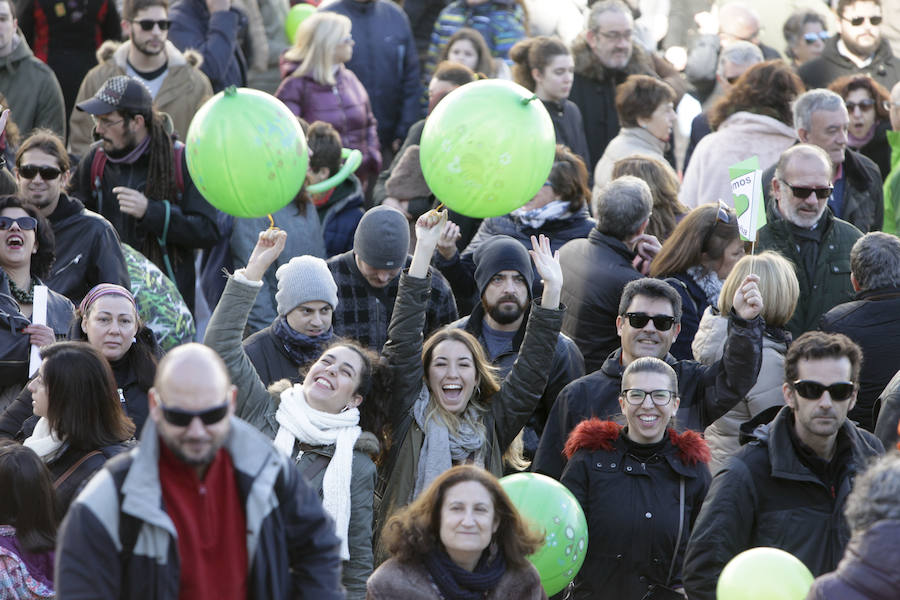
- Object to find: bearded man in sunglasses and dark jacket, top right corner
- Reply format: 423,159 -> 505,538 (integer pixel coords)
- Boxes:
797,0 -> 900,90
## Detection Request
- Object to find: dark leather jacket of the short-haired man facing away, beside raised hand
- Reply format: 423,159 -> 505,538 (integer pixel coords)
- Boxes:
559,228 -> 642,373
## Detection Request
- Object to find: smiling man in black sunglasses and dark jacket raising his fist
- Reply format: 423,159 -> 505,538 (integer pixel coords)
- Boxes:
533,275 -> 765,479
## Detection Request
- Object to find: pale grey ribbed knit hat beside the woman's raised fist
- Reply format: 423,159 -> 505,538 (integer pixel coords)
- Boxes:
275,255 -> 338,317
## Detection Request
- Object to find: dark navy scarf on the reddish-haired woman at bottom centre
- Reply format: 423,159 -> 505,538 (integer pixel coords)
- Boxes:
423,548 -> 506,600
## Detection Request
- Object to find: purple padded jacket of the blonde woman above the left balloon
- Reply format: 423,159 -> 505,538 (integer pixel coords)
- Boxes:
275,58 -> 381,184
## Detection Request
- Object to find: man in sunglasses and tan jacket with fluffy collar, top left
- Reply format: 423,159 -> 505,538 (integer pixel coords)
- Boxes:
69,0 -> 212,156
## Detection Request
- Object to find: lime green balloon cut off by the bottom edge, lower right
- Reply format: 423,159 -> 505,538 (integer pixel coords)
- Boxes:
716,547 -> 813,600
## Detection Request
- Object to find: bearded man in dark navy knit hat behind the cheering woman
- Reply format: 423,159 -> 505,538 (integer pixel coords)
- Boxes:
453,235 -> 584,458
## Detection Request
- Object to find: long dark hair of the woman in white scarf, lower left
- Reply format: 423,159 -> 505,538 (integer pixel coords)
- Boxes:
41,342 -> 134,450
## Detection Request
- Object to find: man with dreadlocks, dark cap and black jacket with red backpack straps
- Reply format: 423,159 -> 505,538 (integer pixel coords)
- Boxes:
75,75 -> 219,310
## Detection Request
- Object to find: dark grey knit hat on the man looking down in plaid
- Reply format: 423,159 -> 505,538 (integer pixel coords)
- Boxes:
353,206 -> 409,269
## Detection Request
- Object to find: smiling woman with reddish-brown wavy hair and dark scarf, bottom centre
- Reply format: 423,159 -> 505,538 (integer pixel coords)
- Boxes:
366,465 -> 547,600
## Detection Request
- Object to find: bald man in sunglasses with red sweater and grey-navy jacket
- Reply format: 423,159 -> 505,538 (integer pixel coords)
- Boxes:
55,344 -> 344,600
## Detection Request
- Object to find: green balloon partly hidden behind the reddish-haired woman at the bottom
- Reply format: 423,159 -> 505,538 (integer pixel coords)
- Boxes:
500,473 -> 587,596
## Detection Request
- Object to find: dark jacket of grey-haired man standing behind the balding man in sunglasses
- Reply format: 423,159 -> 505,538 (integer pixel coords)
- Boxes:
762,148 -> 884,233
